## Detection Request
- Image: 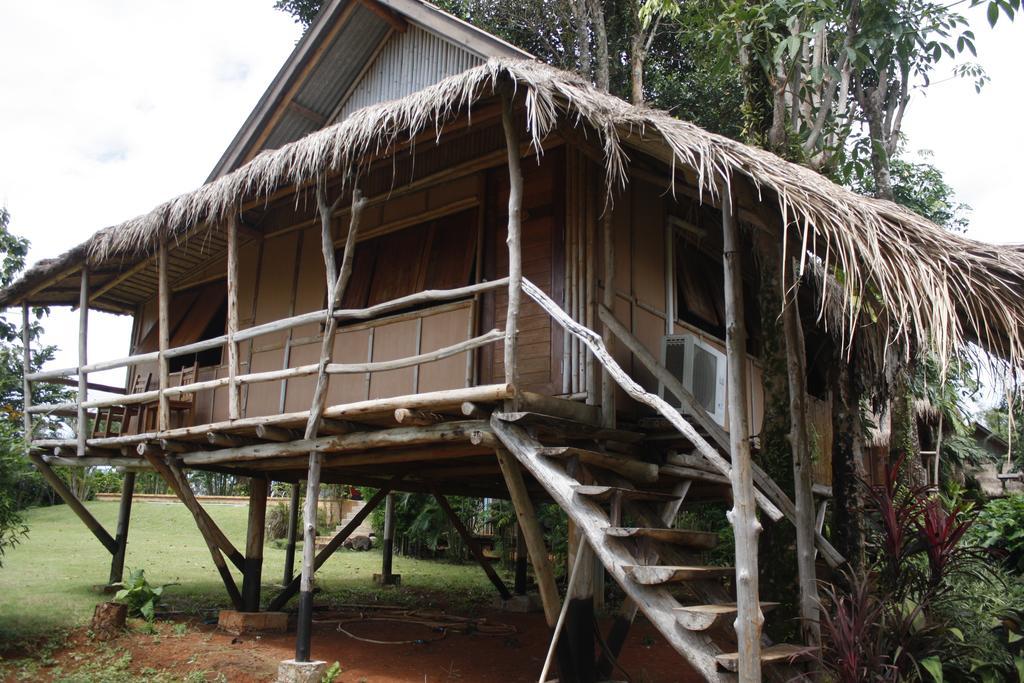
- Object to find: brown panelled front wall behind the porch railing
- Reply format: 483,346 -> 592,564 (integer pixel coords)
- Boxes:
129,139 -> 563,427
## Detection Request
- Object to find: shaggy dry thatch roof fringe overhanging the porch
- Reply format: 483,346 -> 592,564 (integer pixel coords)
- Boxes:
0,59 -> 1024,376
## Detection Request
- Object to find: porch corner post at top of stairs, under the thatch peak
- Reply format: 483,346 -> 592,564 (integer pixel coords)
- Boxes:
502,93 -> 522,397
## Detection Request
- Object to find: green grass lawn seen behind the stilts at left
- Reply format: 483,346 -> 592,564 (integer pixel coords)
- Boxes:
0,501 -> 503,644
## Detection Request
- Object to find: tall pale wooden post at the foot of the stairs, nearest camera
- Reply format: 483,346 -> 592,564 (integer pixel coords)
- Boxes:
722,185 -> 764,683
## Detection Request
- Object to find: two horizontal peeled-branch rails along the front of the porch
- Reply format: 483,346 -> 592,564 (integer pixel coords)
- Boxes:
25,278 -> 509,434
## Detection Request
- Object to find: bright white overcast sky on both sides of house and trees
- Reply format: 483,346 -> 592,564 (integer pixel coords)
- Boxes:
0,0 -> 1024,401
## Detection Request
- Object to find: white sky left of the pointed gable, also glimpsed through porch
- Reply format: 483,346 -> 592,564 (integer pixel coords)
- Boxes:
0,0 -> 299,381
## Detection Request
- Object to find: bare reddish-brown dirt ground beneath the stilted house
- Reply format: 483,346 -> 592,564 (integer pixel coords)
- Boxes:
4,609 -> 700,683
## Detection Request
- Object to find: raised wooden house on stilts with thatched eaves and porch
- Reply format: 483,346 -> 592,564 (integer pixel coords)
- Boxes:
0,0 -> 1024,681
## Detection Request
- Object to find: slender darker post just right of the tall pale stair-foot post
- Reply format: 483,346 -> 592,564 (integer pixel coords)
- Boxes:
779,244 -> 821,647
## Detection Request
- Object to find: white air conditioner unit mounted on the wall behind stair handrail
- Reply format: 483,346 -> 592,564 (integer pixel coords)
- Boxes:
660,334 -> 725,427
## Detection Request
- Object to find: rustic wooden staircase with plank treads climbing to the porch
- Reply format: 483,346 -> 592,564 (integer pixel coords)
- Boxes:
490,413 -> 807,683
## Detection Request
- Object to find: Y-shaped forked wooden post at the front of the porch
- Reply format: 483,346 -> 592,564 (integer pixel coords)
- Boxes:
295,183 -> 366,661
